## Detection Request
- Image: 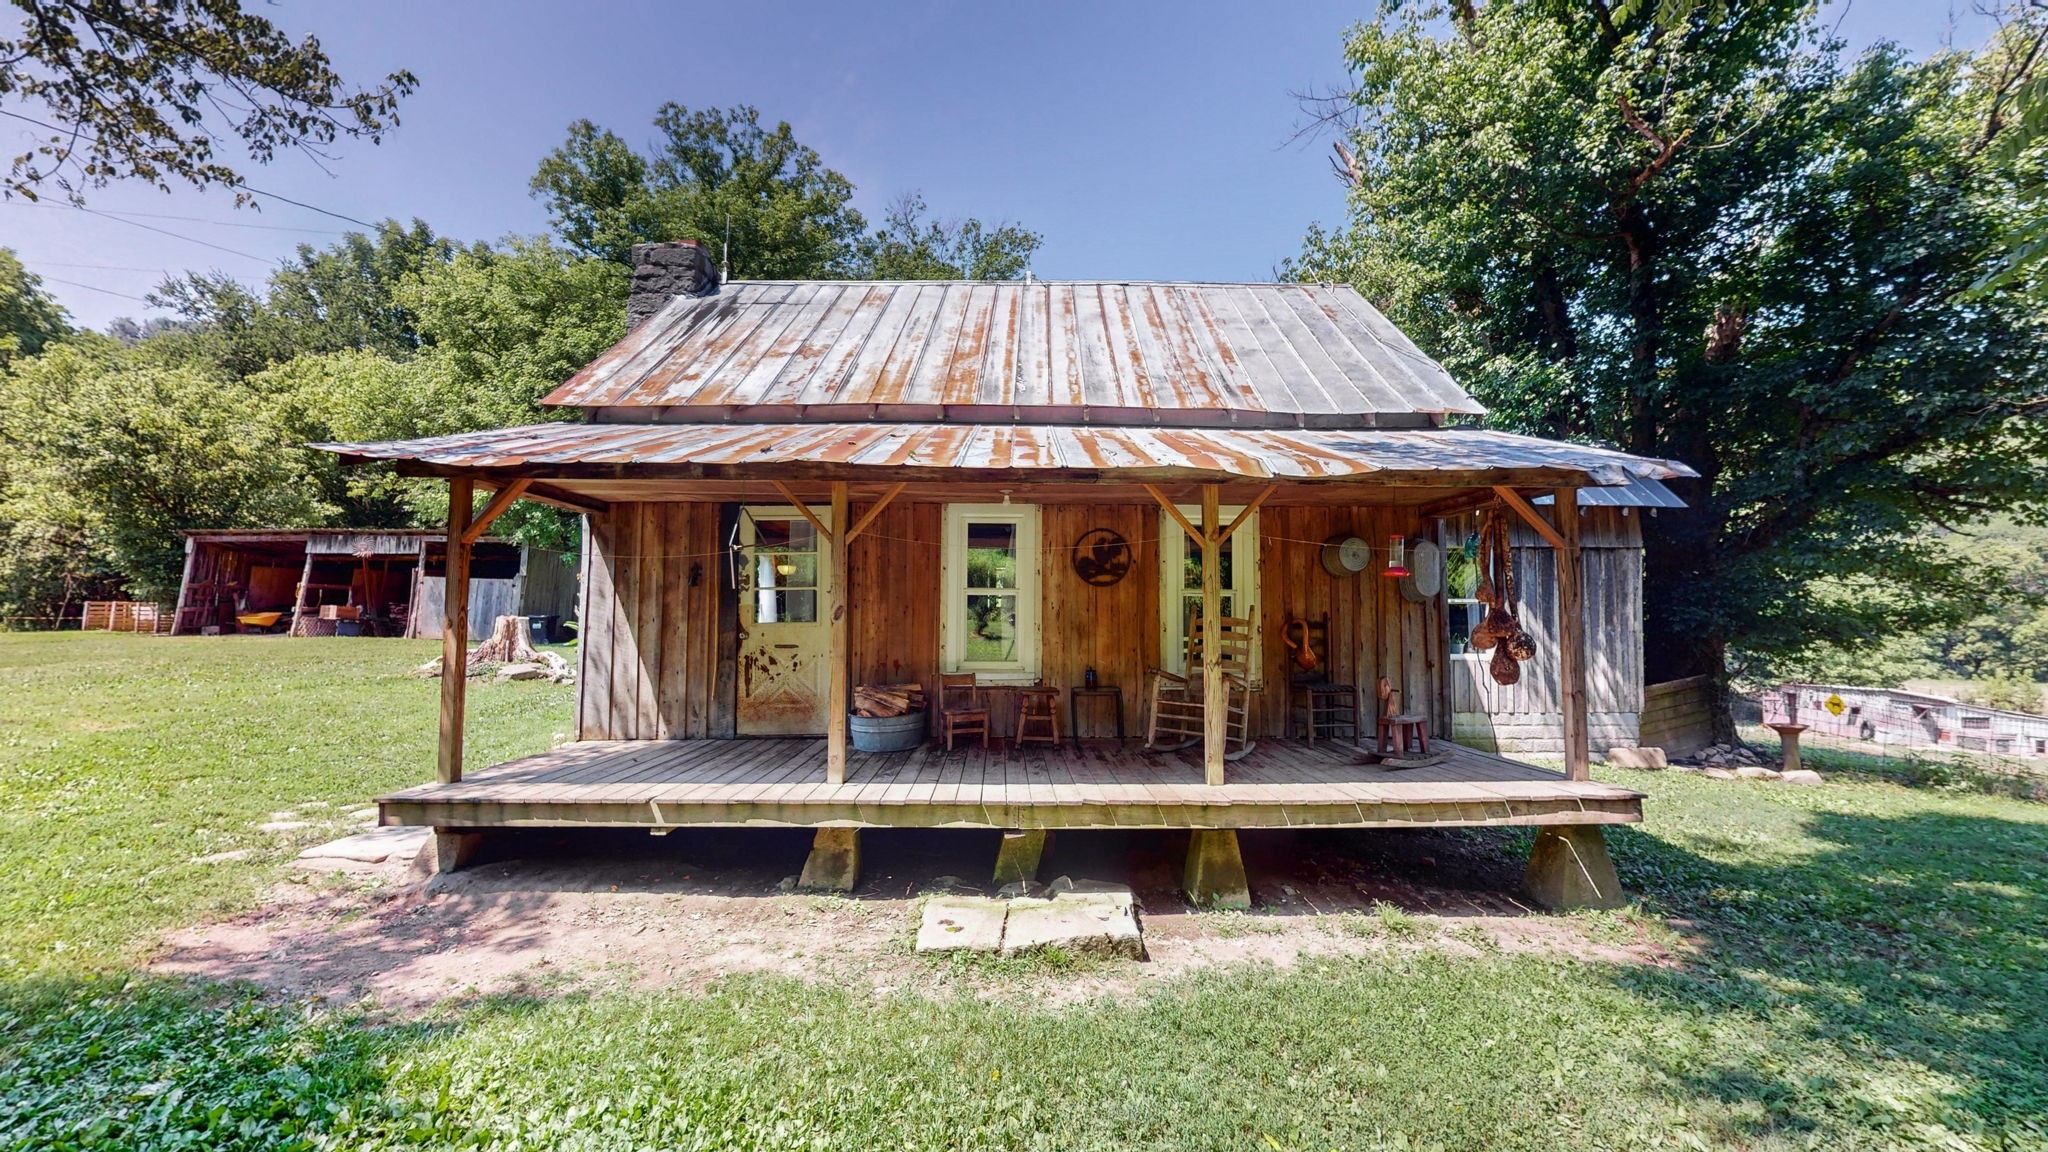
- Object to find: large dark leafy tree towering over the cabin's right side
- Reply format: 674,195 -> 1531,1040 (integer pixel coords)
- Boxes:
1292,0 -> 2048,725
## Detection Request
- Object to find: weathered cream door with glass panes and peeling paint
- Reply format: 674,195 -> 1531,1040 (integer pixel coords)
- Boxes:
737,506 -> 834,736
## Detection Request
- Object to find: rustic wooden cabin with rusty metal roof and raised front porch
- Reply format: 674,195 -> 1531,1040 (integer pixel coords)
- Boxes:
322,244 -> 1692,904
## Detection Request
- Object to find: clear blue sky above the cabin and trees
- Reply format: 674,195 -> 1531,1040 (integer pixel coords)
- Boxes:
0,0 -> 1989,328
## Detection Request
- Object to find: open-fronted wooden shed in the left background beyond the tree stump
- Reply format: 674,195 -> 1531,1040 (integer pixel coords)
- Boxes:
172,529 -> 578,637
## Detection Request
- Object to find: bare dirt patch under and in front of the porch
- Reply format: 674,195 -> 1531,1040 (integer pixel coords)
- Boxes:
154,830 -> 1683,1013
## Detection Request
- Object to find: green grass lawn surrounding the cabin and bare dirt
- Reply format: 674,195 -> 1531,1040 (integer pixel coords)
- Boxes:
0,635 -> 2048,1150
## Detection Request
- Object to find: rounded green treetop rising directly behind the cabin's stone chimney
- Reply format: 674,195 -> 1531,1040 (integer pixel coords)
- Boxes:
532,102 -> 864,279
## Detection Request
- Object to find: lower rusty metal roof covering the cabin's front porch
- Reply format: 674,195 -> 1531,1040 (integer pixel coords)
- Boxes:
315,424 -> 1696,486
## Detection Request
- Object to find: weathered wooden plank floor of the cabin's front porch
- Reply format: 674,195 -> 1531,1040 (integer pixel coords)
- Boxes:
377,738 -> 1642,828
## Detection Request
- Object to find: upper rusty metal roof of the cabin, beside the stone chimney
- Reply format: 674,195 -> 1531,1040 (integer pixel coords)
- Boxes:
545,281 -> 1485,428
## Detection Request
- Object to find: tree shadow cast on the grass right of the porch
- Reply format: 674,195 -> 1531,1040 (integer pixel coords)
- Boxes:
1608,810 -> 2048,1148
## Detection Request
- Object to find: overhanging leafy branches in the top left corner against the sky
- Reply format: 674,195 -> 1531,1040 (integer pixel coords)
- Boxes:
0,0 -> 418,203
